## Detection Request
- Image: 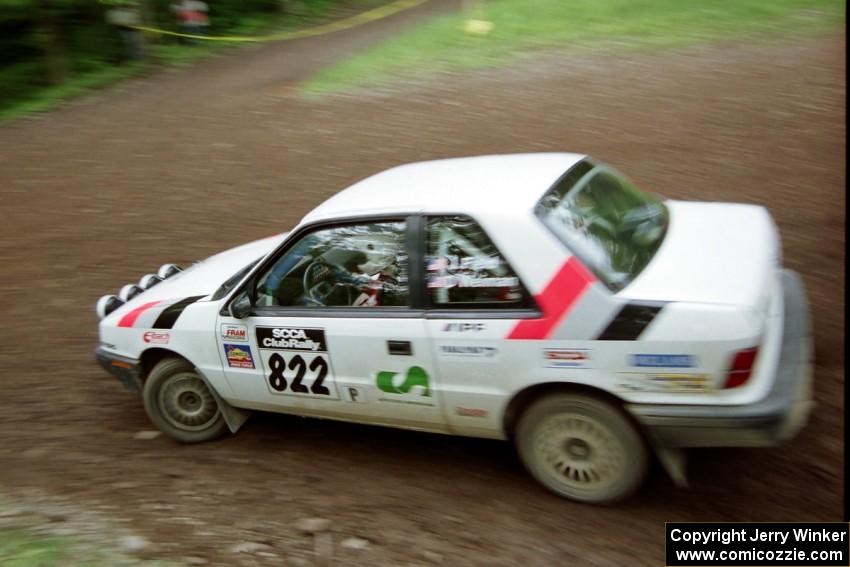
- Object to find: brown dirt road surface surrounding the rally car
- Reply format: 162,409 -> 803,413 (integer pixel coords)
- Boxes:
0,2 -> 846,565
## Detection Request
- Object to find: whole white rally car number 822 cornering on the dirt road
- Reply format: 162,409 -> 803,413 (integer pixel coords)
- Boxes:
96,153 -> 812,502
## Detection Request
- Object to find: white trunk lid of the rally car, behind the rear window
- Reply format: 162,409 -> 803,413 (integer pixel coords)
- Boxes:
619,201 -> 781,310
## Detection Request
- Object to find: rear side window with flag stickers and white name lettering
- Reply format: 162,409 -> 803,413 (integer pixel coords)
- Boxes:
425,216 -> 529,309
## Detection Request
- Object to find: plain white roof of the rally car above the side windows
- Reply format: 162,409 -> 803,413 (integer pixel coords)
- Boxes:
302,153 -> 585,223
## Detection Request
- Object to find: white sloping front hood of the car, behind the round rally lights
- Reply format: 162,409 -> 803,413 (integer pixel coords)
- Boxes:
102,233 -> 288,317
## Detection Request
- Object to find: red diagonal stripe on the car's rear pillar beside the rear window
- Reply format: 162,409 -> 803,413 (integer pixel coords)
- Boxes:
508,256 -> 596,340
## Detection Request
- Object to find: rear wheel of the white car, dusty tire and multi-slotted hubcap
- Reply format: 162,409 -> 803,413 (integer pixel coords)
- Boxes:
515,394 -> 649,504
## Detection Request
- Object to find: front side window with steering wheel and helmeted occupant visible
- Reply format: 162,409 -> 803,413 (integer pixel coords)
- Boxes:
257,221 -> 408,307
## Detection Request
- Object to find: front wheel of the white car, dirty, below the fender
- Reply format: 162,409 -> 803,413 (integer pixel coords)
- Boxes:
142,358 -> 227,443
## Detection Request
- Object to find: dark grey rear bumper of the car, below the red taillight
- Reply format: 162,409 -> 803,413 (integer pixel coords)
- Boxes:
626,270 -> 814,448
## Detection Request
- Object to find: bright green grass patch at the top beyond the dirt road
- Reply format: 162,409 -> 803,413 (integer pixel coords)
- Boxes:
302,0 -> 845,94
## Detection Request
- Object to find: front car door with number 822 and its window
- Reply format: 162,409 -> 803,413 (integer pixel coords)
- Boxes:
218,218 -> 445,430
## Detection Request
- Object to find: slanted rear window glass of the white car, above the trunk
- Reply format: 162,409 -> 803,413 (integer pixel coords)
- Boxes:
537,161 -> 668,291
